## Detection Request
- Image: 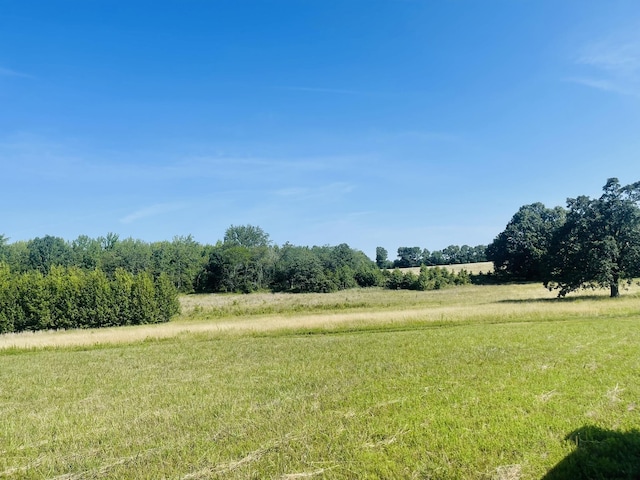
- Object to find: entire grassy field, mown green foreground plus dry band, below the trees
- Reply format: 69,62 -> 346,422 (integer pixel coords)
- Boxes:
0,285 -> 640,480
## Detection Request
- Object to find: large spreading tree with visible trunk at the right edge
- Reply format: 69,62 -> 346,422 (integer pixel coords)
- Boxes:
544,178 -> 640,297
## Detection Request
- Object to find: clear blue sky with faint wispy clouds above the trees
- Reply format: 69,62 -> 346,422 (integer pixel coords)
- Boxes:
0,0 -> 640,258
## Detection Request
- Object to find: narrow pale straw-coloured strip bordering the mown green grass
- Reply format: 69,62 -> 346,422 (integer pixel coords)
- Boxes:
0,296 -> 620,349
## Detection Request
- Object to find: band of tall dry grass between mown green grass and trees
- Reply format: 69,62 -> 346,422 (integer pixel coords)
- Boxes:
0,284 -> 640,349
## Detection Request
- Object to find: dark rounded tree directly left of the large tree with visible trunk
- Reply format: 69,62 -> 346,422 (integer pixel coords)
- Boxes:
487,203 -> 565,280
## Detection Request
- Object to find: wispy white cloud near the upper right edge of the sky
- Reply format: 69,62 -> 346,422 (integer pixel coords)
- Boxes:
566,26 -> 640,97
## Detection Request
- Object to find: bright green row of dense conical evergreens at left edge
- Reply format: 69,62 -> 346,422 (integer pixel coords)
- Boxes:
0,264 -> 180,333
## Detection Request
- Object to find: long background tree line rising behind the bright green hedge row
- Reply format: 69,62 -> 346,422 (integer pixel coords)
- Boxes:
0,225 -> 473,300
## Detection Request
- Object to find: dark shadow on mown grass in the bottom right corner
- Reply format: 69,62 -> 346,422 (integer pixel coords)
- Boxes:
542,426 -> 640,480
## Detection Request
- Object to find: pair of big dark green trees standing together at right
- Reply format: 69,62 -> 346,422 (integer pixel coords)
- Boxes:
487,178 -> 640,297
